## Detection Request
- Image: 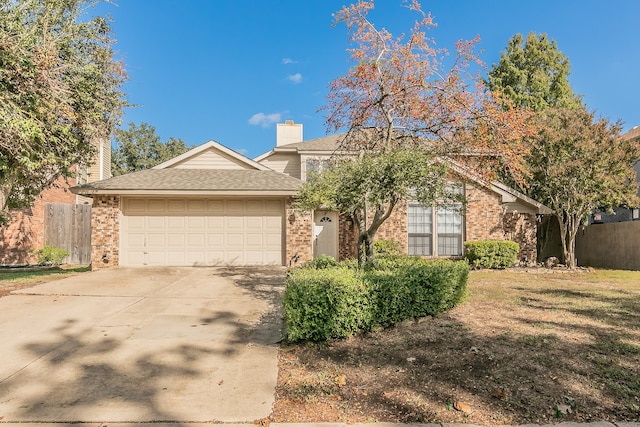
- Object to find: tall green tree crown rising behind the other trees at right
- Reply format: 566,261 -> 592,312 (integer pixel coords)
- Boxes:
487,33 -> 581,111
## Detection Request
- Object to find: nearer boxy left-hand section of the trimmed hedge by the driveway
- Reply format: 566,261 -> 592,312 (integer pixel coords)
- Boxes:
284,267 -> 371,341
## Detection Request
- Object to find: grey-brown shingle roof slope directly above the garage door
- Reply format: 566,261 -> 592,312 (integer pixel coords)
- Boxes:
76,169 -> 302,194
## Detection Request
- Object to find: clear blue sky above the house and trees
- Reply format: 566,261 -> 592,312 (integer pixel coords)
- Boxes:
97,0 -> 640,157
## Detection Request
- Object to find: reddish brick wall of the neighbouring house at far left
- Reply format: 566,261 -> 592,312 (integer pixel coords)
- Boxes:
0,178 -> 76,265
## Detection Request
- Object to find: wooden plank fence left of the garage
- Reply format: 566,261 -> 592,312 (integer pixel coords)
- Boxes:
44,203 -> 91,265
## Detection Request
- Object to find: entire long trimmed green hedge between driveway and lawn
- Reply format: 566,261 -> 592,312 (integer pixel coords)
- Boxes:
284,257 -> 469,341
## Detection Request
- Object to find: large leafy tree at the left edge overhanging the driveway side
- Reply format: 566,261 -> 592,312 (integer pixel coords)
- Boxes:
0,0 -> 126,218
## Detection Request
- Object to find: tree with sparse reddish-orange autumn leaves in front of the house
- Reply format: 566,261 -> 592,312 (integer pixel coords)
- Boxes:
298,0 -> 530,261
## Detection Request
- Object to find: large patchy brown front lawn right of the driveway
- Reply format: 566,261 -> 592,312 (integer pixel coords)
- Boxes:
271,270 -> 640,425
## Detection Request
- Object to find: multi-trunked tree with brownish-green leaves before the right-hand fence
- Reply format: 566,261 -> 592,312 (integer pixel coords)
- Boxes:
529,107 -> 640,268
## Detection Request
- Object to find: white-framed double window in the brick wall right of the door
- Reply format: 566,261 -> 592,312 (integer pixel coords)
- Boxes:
408,204 -> 462,256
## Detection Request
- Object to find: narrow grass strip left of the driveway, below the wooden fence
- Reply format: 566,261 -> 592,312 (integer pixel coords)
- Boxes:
0,265 -> 91,297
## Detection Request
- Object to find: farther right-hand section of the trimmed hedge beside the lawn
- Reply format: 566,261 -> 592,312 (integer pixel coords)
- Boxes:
365,257 -> 469,326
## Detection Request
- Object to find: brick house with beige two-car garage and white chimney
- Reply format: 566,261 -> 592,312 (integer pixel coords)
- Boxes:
72,121 -> 546,268
